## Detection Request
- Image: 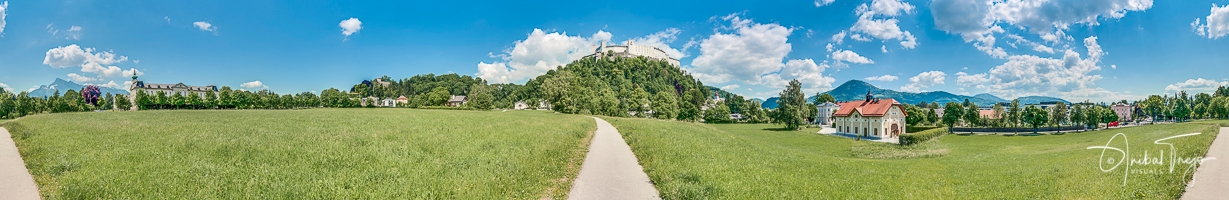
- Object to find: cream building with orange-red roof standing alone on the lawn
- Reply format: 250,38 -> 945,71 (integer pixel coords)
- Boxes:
832,92 -> 907,139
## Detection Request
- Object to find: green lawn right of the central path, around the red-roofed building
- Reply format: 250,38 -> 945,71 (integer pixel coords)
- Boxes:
607,118 -> 1224,199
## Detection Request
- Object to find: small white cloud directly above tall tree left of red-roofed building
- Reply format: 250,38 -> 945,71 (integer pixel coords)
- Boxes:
762,59 -> 836,93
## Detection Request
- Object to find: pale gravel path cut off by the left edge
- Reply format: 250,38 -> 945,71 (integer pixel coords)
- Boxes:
0,128 -> 39,200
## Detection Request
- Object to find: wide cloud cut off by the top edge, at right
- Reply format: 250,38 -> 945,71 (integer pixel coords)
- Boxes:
930,0 -> 1153,58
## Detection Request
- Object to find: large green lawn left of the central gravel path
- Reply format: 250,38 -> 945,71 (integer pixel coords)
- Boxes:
5,109 -> 596,199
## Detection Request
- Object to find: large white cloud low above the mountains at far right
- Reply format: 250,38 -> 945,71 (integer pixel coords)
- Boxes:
987,37 -> 1105,98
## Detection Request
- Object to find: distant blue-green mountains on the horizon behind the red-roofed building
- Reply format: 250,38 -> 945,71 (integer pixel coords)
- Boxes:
747,80 -> 1070,109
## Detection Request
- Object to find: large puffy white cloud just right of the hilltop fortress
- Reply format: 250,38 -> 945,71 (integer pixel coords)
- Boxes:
688,13 -> 794,83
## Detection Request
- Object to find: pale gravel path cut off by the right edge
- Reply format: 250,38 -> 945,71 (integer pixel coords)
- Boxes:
1182,128 -> 1229,199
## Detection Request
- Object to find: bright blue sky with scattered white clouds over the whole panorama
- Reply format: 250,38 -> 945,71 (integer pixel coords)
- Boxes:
0,0 -> 1229,102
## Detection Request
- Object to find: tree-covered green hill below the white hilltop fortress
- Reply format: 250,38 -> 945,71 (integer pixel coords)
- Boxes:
525,56 -> 710,118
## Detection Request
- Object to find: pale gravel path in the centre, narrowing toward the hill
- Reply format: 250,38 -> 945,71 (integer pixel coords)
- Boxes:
568,118 -> 661,199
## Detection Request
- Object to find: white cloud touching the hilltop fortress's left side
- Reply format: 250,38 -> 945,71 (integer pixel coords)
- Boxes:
477,28 -> 611,83
